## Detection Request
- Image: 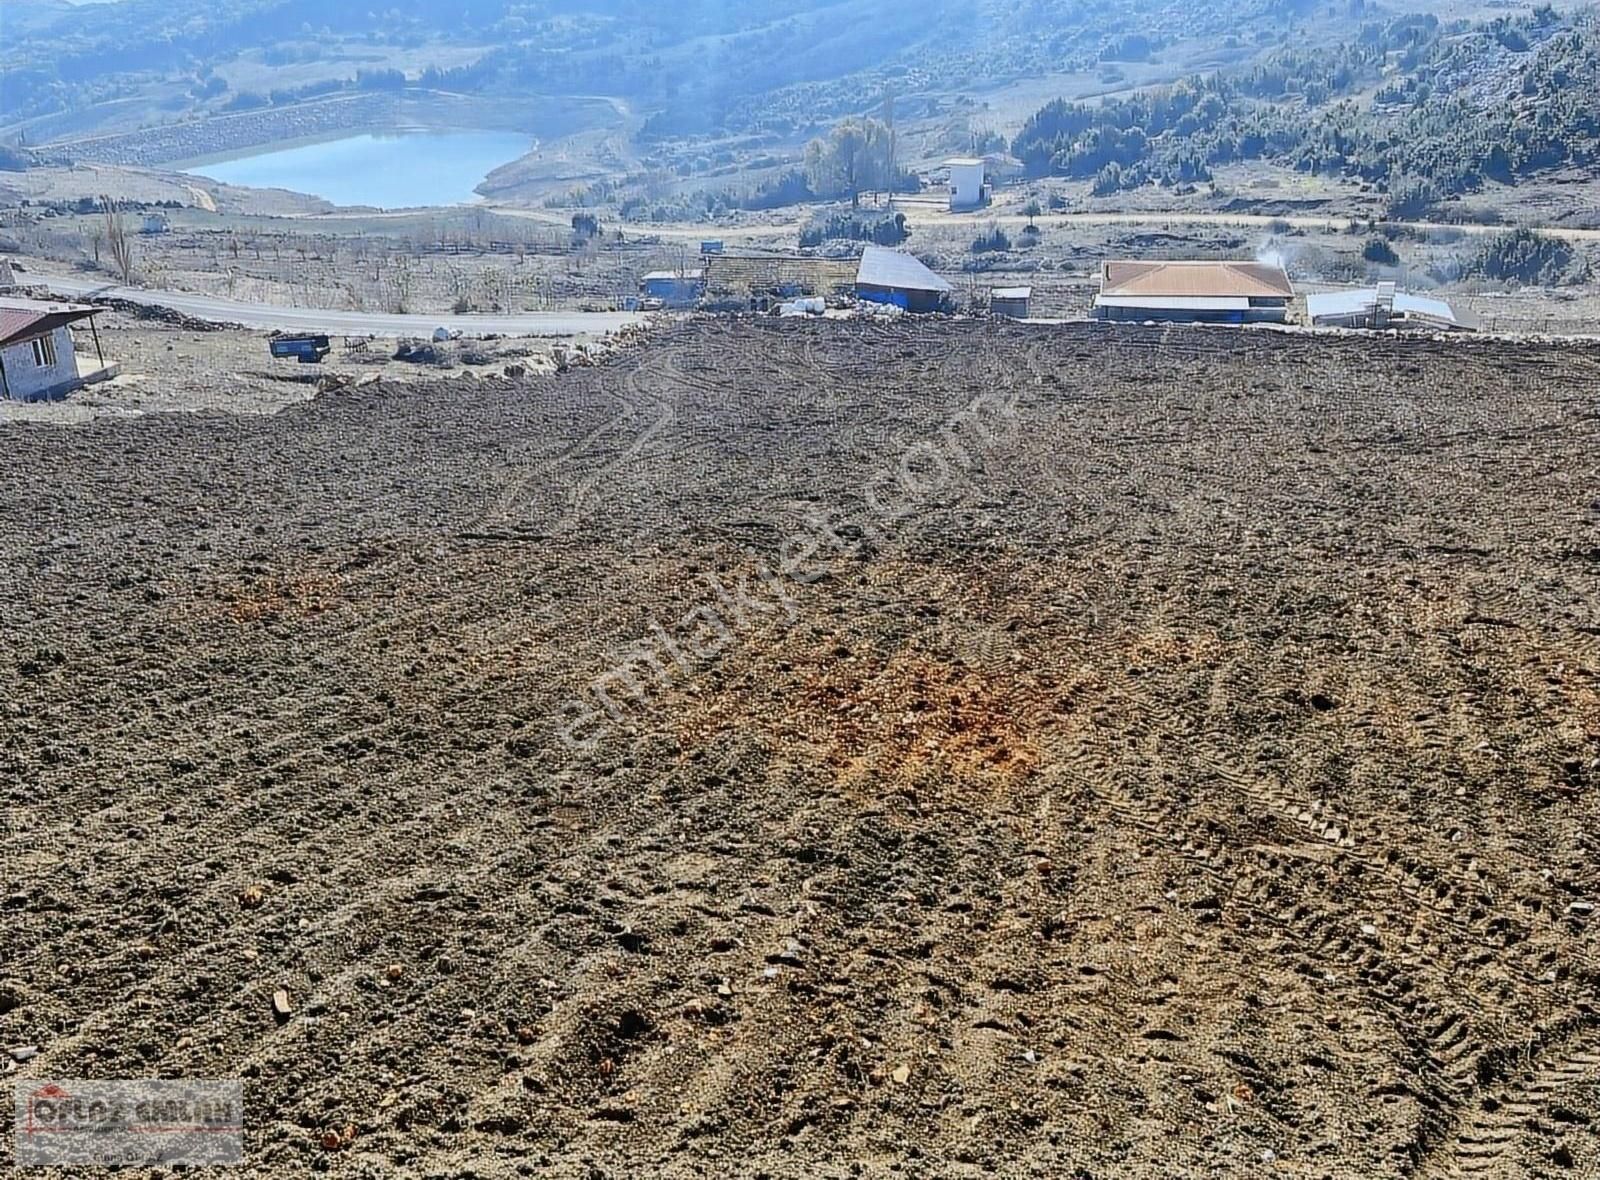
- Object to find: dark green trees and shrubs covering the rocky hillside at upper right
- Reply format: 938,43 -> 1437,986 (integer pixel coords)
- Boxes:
1013,8 -> 1600,214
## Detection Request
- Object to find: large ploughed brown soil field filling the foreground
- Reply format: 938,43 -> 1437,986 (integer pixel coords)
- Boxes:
0,321 -> 1600,1177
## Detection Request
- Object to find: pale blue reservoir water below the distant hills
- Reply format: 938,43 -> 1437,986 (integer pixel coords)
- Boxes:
189,131 -> 533,209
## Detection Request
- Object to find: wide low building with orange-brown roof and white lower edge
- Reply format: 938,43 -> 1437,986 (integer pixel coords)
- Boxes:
1094,261 -> 1294,323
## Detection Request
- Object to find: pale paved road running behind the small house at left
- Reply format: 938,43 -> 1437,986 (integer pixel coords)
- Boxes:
24,272 -> 643,336
